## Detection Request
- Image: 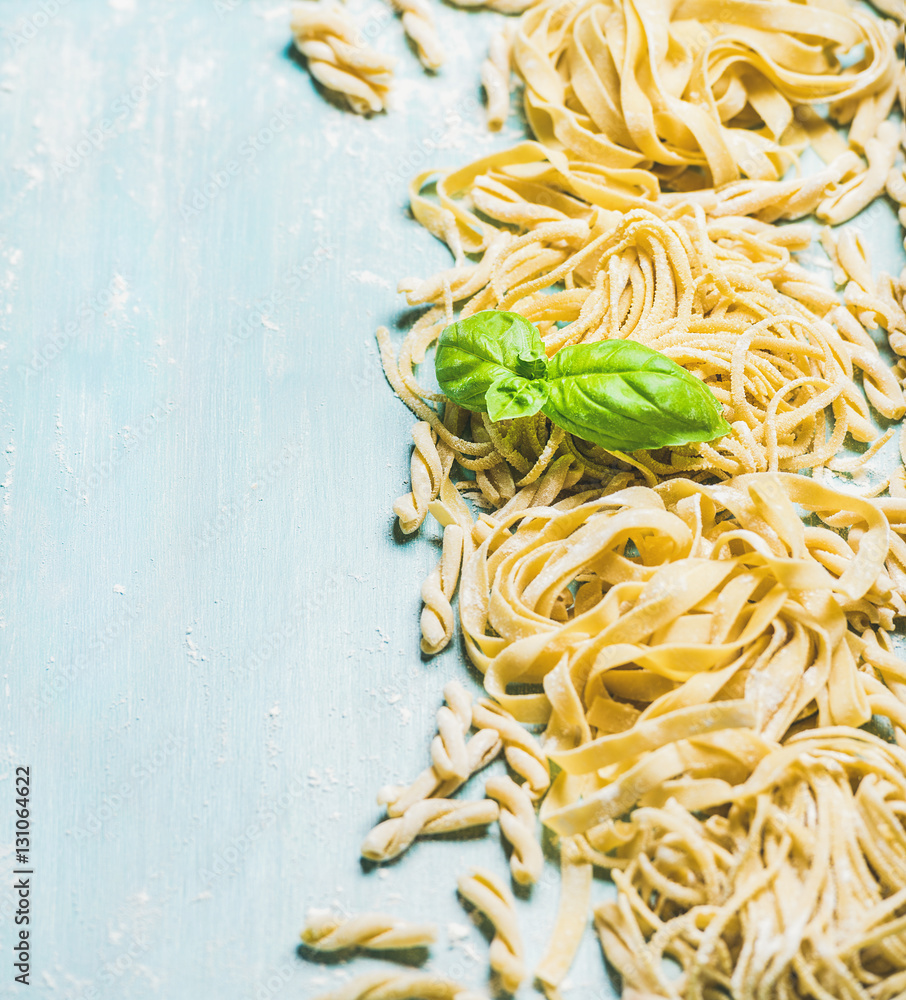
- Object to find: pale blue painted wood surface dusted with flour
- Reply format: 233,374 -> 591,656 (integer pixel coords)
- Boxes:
0,0 -> 898,1000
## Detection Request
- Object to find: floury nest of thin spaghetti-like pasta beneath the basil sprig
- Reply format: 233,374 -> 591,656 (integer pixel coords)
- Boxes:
384,199 -> 906,510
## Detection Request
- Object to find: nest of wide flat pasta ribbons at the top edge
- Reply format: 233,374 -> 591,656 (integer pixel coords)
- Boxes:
514,0 -> 897,188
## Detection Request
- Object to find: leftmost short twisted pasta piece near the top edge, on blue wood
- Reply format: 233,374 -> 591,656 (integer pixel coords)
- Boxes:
290,2 -> 393,115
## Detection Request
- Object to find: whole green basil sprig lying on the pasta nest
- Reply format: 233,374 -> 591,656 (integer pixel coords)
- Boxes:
434,311 -> 730,451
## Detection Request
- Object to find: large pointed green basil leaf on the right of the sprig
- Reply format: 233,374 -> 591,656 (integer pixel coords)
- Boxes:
543,340 -> 730,451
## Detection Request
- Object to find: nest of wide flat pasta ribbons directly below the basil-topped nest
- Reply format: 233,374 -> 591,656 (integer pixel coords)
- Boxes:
460,475 -> 906,752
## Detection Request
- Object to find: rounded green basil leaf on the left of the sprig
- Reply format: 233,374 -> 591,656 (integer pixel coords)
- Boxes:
434,310 -> 547,413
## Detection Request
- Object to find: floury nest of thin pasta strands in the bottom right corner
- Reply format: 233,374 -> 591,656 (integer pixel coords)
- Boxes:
595,729 -> 906,1000
